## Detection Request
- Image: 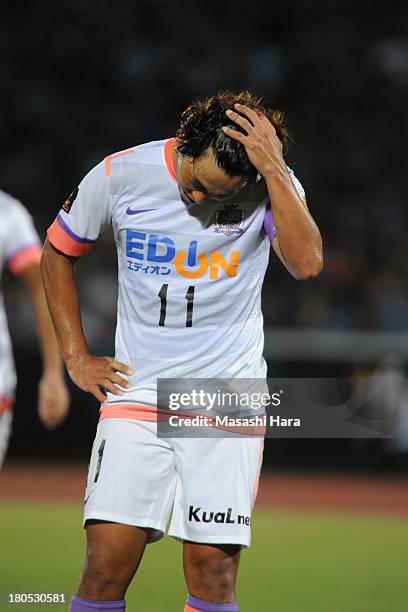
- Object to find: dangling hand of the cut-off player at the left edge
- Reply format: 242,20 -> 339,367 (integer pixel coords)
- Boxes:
38,372 -> 70,429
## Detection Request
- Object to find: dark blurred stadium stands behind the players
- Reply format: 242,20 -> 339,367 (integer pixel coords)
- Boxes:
0,0 -> 408,471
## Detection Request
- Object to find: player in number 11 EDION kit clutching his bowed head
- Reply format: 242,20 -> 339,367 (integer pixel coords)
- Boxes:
42,92 -> 322,612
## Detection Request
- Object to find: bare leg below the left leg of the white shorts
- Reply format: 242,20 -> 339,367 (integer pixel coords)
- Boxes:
71,521 -> 151,612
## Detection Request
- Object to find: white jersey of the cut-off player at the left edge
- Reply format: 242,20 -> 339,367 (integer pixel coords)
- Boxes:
0,191 -> 41,414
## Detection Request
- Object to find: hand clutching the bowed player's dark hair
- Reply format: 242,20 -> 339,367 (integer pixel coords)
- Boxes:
222,104 -> 286,176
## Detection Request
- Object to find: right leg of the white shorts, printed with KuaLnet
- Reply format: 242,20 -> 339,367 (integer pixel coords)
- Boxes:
169,433 -> 263,546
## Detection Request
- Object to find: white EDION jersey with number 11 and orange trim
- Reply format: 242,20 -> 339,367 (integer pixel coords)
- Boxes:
48,139 -> 303,418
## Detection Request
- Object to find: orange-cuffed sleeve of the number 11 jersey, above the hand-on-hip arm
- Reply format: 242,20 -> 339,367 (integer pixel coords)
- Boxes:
47,162 -> 111,257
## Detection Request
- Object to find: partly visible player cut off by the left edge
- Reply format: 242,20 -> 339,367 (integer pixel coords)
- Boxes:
0,191 -> 69,465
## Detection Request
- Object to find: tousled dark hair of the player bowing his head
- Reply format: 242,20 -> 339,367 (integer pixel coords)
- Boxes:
176,91 -> 289,183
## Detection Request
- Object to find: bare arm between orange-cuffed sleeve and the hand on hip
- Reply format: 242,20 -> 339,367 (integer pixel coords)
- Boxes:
41,240 -> 88,366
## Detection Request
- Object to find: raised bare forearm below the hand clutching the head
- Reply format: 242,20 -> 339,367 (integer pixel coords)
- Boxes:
264,168 -> 323,279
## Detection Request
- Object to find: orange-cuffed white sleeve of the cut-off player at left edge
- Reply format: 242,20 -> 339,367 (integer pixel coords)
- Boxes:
3,198 -> 41,274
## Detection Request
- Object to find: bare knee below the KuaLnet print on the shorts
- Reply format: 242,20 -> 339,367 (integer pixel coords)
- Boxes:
183,542 -> 241,612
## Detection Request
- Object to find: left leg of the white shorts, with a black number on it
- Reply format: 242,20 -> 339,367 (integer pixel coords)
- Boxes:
84,418 -> 175,541
